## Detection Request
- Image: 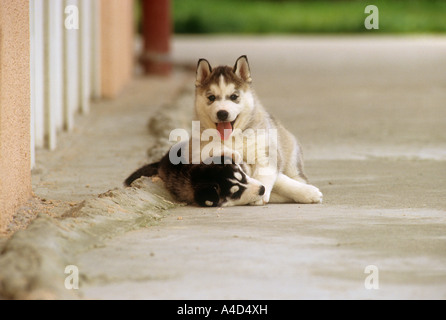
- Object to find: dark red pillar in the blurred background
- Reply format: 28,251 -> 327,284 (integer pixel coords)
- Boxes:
142,0 -> 172,75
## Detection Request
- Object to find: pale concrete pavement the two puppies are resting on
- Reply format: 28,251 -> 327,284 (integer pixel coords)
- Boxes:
0,36 -> 446,299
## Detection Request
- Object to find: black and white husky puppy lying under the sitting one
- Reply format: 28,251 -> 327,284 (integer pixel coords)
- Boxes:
124,153 -> 265,207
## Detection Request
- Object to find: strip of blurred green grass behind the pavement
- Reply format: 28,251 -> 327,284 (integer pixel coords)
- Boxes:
173,0 -> 446,34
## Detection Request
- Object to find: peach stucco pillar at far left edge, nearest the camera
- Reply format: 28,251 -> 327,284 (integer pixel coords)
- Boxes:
0,0 -> 31,232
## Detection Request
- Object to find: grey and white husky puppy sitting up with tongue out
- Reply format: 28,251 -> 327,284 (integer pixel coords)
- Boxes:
190,56 -> 322,205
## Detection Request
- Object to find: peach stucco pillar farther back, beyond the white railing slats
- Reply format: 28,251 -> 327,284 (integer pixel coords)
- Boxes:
101,0 -> 134,98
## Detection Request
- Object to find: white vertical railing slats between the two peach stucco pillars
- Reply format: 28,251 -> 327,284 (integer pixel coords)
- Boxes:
30,0 -> 101,166
